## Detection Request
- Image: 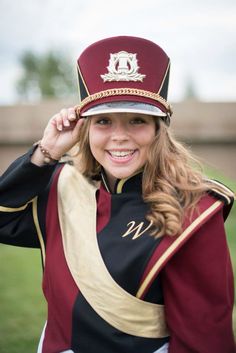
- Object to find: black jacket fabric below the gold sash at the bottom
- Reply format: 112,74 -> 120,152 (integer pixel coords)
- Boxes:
71,294 -> 169,353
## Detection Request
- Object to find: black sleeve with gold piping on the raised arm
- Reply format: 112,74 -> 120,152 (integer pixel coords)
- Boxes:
0,148 -> 56,248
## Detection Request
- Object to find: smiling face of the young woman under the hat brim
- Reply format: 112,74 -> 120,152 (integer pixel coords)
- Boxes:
89,113 -> 156,188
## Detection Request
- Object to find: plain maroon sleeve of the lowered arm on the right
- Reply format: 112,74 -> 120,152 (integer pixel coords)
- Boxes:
162,209 -> 235,353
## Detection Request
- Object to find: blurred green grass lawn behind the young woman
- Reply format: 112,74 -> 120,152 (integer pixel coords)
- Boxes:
0,169 -> 236,353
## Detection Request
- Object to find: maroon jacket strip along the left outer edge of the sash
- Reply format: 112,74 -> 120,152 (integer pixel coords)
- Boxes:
43,168 -> 79,353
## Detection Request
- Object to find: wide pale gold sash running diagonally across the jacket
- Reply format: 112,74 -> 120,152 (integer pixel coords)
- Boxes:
58,165 -> 168,338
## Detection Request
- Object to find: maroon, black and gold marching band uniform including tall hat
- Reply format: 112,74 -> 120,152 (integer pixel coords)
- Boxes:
0,37 -> 235,353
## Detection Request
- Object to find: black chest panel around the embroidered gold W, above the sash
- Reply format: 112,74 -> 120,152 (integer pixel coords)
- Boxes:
98,193 -> 162,303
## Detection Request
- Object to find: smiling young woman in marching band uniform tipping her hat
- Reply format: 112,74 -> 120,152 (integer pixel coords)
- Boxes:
0,37 -> 235,353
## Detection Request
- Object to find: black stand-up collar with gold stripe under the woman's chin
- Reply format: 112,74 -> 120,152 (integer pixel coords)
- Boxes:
101,170 -> 143,194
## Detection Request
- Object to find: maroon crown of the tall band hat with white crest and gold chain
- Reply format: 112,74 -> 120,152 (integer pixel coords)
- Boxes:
77,36 -> 171,116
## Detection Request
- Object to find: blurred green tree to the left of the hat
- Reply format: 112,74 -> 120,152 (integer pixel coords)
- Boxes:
16,51 -> 77,101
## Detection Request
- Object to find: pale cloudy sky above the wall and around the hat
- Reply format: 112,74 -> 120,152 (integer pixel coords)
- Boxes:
0,0 -> 236,105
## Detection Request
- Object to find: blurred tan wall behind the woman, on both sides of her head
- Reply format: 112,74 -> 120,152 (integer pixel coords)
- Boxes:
0,99 -> 236,180
